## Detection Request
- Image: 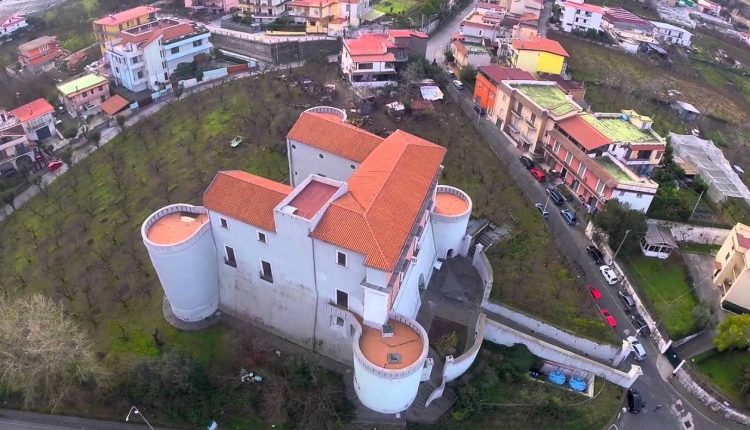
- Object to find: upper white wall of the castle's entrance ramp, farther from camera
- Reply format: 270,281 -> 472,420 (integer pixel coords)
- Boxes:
482,301 -> 621,362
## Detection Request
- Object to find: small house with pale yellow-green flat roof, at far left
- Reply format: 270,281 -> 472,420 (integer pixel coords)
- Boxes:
57,75 -> 110,118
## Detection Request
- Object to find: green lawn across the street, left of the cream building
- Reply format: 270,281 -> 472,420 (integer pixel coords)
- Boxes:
620,252 -> 698,340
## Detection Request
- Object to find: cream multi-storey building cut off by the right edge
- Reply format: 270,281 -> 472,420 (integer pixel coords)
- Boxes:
713,223 -> 750,314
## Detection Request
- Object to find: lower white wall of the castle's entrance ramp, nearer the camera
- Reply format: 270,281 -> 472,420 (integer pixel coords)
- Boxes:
484,320 -> 643,388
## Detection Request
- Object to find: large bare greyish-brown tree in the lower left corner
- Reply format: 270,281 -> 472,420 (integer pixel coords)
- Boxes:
0,294 -> 105,412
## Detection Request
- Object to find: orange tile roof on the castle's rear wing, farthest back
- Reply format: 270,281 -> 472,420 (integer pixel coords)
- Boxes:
286,112 -> 383,163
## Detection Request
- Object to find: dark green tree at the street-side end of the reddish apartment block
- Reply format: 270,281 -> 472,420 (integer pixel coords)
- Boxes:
594,199 -> 647,252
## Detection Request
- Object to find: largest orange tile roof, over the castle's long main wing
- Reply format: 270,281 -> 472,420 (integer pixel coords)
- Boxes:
313,130 -> 446,271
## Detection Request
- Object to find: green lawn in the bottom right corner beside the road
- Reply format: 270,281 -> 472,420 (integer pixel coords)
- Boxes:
693,350 -> 750,405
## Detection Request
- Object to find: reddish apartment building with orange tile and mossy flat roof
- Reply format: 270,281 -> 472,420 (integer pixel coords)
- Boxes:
544,114 -> 659,212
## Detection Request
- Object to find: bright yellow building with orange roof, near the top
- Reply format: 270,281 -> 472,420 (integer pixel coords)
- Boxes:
510,37 -> 568,75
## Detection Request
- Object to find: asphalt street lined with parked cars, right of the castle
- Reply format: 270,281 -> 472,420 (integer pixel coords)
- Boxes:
448,87 -> 745,430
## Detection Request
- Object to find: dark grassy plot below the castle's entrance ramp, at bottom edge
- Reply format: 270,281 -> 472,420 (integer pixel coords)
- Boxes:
414,343 -> 625,430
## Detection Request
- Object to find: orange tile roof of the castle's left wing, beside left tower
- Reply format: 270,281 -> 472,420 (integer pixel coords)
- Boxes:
203,170 -> 292,232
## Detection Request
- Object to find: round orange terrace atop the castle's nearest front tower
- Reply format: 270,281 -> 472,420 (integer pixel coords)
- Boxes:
359,319 -> 422,369
